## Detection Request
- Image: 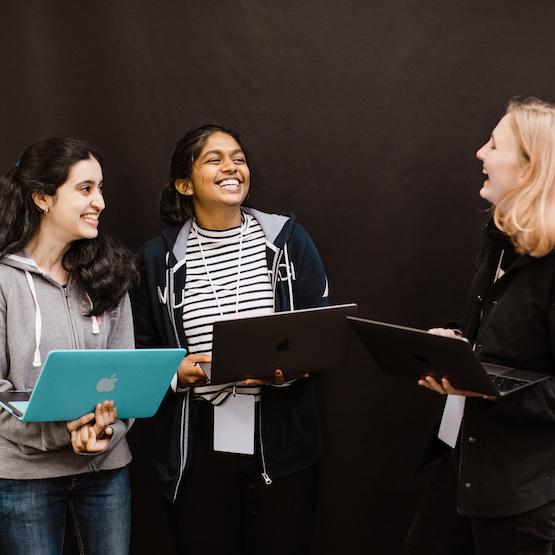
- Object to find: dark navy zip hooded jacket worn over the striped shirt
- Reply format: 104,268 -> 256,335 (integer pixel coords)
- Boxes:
131,210 -> 328,501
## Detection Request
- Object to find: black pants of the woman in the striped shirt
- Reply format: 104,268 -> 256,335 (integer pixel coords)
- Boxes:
169,401 -> 318,555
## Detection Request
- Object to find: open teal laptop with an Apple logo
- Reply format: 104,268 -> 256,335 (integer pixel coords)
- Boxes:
0,349 -> 186,422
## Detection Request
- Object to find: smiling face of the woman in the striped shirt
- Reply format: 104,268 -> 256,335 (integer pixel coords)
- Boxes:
175,131 -> 250,217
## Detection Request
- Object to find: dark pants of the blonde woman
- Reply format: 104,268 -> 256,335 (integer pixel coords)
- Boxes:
403,453 -> 555,555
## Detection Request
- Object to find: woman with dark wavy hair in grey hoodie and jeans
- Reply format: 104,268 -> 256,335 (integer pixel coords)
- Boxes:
0,138 -> 136,555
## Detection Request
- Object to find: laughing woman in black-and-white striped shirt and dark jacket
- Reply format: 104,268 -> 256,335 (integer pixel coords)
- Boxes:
133,125 -> 328,554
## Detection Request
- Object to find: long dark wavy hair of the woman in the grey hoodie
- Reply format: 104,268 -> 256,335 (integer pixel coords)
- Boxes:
0,137 -> 137,316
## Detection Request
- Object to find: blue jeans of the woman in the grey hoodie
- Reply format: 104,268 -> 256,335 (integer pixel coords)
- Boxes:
0,468 -> 131,555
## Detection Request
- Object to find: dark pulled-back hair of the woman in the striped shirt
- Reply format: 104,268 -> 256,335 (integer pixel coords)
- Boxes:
160,123 -> 247,225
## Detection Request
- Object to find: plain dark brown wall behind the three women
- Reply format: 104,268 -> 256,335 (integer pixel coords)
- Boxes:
0,0 -> 555,555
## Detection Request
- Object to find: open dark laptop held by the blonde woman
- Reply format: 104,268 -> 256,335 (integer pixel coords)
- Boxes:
348,317 -> 551,397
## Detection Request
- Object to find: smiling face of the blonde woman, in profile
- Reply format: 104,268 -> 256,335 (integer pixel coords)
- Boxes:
476,115 -> 528,205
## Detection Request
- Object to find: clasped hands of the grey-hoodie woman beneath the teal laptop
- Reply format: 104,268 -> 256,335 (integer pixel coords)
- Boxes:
66,401 -> 117,453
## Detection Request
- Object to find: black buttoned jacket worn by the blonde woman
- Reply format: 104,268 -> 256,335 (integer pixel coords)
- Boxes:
458,222 -> 555,517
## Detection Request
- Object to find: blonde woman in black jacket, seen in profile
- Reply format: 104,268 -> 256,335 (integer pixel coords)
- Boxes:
404,98 -> 555,555
